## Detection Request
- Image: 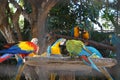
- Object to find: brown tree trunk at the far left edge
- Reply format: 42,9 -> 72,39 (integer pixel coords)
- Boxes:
0,0 -> 14,43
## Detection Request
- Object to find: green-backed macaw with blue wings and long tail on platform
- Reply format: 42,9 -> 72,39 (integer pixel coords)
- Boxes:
66,40 -> 113,80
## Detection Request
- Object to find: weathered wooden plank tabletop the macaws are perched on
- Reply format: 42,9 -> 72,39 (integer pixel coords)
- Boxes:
25,57 -> 117,69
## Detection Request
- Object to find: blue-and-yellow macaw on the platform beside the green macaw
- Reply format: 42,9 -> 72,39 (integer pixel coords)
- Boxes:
47,38 -> 66,57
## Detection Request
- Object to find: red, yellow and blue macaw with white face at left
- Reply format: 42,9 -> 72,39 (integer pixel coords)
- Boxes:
0,38 -> 38,63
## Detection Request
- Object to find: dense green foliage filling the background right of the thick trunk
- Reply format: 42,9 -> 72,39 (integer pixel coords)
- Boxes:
48,0 -> 119,34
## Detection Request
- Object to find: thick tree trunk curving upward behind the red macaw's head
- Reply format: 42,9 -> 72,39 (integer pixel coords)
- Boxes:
32,0 -> 59,54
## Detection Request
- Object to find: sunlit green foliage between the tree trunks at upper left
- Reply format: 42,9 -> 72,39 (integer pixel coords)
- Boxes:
6,0 -> 32,40
